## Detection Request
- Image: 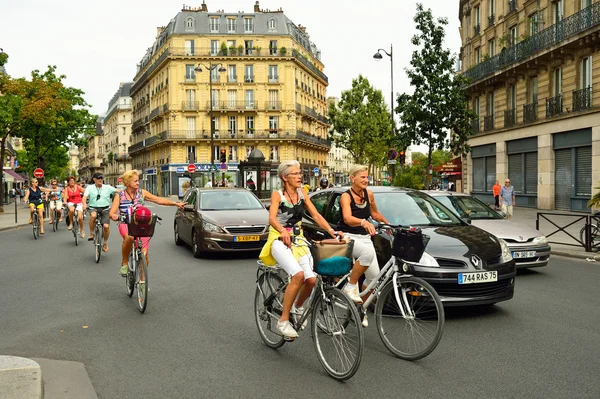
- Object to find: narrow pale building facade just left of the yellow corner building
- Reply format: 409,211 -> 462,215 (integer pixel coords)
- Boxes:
100,82 -> 133,186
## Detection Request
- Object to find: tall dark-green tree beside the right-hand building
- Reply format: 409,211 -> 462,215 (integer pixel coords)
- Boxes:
396,4 -> 476,172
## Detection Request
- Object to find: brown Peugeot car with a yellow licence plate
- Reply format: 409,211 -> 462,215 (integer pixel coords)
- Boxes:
173,187 -> 269,258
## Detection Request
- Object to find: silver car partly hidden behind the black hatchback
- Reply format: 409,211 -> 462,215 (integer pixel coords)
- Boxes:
425,191 -> 550,269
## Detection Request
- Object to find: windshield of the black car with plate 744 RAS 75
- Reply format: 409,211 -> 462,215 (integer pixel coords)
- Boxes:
374,192 -> 462,226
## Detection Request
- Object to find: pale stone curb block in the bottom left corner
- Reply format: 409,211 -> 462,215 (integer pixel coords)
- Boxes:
0,356 -> 44,399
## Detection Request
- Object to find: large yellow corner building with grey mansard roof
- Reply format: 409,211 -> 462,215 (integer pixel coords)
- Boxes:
129,2 -> 330,195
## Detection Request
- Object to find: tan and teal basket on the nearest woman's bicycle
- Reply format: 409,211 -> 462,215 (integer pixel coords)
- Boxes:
310,239 -> 354,276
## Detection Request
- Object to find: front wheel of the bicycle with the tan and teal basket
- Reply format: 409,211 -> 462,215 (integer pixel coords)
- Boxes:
311,288 -> 364,381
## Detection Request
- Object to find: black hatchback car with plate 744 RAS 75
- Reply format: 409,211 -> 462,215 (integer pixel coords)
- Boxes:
302,187 -> 516,306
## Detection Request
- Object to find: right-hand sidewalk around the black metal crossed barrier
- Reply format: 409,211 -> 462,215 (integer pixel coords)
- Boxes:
511,207 -> 600,262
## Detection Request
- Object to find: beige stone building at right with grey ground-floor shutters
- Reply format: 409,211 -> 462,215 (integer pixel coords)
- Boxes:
459,0 -> 600,211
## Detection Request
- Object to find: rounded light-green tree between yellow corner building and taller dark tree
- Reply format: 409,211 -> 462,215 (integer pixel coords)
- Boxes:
329,75 -> 391,172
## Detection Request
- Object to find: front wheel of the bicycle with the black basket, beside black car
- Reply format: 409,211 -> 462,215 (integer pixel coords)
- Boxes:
375,276 -> 444,360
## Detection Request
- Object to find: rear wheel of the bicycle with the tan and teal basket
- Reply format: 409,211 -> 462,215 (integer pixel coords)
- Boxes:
254,271 -> 285,349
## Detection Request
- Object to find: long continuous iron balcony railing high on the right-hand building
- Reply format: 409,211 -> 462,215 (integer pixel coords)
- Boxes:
464,2 -> 600,81
